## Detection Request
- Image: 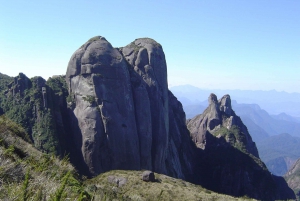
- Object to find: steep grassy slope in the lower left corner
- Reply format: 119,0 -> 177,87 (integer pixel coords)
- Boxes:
0,116 -> 87,200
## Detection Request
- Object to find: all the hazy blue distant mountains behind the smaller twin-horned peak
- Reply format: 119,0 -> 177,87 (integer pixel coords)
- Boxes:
171,85 -> 300,176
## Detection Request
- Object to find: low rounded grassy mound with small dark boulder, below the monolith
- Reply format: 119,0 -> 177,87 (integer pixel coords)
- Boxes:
85,170 -> 253,201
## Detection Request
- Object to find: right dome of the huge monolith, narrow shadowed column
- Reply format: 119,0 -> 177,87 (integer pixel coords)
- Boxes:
121,38 -> 169,173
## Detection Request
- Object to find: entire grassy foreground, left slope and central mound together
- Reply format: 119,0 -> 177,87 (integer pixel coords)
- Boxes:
0,116 -> 251,201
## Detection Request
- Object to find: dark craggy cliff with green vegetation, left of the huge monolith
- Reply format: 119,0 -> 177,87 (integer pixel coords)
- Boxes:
0,73 -> 67,155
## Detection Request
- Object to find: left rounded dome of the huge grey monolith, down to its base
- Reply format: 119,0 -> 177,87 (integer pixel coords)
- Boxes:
66,37 -> 140,175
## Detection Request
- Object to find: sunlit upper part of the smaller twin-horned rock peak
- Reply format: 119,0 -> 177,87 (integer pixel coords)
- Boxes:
187,94 -> 258,158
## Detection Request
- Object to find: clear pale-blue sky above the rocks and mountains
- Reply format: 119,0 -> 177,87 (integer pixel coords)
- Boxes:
0,0 -> 300,92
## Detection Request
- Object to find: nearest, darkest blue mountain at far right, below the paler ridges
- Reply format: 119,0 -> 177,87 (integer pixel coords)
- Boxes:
256,133 -> 300,176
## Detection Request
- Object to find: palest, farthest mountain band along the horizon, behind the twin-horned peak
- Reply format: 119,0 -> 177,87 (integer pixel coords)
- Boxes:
170,85 -> 300,117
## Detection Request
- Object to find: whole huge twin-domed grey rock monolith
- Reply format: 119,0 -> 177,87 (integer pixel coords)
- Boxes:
66,37 -> 192,178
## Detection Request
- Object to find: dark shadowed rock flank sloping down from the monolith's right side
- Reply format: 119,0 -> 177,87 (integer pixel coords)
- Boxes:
166,91 -> 198,180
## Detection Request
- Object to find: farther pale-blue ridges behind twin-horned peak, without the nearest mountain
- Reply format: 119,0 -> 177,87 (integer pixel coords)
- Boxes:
171,85 -> 300,138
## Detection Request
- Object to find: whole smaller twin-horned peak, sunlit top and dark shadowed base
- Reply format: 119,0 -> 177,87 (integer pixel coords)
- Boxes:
187,94 -> 295,200
